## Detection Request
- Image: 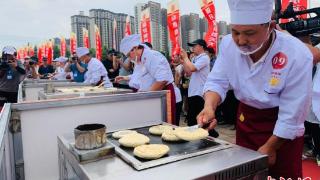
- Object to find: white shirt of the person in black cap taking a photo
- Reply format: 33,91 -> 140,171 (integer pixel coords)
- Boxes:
188,53 -> 210,97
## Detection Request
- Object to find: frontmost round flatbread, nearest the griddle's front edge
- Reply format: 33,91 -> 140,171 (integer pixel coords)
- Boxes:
133,144 -> 170,159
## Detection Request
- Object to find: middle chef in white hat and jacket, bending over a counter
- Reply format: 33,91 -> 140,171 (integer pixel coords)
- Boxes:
116,34 -> 182,124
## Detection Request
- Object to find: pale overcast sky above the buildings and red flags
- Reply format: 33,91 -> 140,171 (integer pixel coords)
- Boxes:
0,0 -> 320,49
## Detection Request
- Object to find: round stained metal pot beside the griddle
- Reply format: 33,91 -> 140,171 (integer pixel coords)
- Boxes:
74,124 -> 106,150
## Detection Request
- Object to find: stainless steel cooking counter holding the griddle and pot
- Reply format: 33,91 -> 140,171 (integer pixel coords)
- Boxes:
58,130 -> 268,180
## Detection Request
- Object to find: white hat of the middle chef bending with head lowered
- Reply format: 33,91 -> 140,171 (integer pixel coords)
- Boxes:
120,34 -> 141,55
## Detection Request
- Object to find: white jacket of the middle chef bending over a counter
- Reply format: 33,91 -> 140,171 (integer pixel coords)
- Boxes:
129,47 -> 182,102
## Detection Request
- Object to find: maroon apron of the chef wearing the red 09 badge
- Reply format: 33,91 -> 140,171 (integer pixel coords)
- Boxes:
236,102 -> 303,179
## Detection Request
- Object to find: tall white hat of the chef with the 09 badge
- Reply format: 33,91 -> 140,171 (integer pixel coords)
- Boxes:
228,0 -> 274,25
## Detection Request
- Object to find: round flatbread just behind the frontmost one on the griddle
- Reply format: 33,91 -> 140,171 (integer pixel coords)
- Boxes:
119,133 -> 150,147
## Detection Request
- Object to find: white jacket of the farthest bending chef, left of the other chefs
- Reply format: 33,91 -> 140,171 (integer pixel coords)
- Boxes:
83,58 -> 112,87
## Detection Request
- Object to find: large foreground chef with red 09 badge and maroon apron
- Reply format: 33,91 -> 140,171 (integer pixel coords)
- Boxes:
197,0 -> 313,179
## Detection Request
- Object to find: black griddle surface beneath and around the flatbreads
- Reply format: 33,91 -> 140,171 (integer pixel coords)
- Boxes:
107,126 -> 220,162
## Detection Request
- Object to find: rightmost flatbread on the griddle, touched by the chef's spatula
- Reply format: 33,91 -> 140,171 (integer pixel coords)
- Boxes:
174,128 -> 209,141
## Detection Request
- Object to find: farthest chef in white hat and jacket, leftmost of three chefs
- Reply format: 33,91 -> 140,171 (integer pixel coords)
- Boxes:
76,47 -> 113,88
